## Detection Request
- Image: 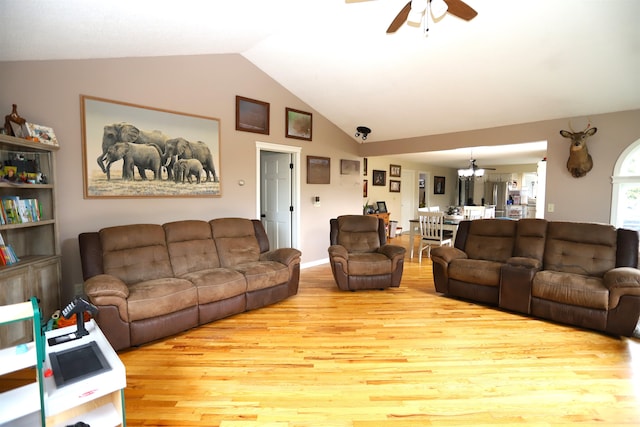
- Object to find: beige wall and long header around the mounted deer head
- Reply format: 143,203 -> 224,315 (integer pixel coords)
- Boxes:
360,110 -> 640,223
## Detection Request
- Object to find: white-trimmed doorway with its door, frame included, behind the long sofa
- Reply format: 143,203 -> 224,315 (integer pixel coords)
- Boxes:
256,142 -> 301,249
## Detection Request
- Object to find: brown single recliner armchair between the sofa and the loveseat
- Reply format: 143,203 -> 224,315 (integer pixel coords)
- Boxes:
329,215 -> 406,291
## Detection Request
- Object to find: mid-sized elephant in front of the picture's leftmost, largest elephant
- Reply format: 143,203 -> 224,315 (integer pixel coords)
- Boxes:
105,142 -> 162,181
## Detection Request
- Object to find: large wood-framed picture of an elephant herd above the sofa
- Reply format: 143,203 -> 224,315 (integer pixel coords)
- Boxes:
80,95 -> 222,199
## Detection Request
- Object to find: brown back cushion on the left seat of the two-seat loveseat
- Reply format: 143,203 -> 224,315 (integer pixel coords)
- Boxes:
464,219 -> 517,263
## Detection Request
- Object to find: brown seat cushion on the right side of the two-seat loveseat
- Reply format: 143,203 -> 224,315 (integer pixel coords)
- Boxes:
531,270 -> 609,310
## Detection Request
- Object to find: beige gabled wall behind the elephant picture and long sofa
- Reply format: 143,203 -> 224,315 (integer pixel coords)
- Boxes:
0,55 -> 362,300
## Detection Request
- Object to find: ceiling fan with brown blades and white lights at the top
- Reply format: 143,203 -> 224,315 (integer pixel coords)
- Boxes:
387,0 -> 478,33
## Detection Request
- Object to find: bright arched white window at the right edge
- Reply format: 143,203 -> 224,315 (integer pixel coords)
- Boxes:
611,139 -> 640,231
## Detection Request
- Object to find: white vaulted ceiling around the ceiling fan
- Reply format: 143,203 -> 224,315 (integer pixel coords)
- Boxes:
0,0 -> 640,164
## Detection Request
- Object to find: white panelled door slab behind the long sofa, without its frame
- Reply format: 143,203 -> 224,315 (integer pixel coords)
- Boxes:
260,151 -> 293,249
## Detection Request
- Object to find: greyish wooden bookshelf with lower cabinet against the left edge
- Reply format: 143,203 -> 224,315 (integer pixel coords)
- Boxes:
0,135 -> 61,345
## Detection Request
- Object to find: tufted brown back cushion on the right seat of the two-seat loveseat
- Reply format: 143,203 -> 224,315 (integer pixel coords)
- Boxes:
544,221 -> 617,277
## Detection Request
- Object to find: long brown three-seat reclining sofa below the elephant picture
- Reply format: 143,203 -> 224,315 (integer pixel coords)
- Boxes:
78,218 -> 301,350
